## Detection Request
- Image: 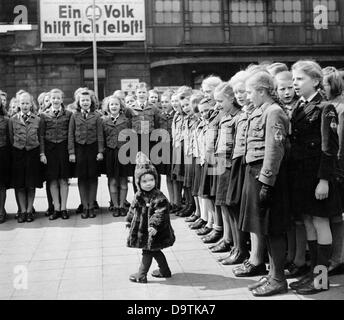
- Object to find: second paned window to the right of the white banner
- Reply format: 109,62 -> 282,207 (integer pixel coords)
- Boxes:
189,0 -> 221,24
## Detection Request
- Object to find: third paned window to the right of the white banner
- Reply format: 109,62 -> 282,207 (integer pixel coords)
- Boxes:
230,0 -> 266,25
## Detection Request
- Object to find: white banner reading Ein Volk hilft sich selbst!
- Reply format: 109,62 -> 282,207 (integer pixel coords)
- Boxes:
40,0 -> 146,42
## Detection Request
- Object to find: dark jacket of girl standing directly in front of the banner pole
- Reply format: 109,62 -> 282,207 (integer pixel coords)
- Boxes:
68,111 -> 104,154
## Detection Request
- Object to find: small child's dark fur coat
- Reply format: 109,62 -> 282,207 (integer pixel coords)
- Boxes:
126,188 -> 175,250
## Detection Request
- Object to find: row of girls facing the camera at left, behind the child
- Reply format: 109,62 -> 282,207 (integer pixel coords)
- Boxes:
0,83 -> 173,223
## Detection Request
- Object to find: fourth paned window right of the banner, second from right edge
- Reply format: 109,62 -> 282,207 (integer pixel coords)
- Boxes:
272,0 -> 302,23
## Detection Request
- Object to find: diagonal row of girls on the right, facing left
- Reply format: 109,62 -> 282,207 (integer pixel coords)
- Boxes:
163,61 -> 344,297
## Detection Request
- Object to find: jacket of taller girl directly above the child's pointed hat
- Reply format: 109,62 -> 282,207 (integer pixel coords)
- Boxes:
128,101 -> 160,134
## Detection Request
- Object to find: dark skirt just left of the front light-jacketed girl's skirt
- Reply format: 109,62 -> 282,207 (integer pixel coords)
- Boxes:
226,157 -> 246,212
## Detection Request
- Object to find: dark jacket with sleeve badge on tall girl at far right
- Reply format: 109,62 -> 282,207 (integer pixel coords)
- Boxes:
290,93 -> 339,180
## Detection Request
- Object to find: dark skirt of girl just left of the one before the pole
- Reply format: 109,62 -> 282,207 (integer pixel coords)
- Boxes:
45,141 -> 72,181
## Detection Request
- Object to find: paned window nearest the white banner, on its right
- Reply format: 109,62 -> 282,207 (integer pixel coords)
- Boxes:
155,0 -> 182,24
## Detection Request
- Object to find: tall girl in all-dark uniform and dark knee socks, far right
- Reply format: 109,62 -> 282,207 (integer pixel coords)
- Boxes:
290,61 -> 341,294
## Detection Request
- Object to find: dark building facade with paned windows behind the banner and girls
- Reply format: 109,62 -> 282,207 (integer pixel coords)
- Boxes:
0,0 -> 344,102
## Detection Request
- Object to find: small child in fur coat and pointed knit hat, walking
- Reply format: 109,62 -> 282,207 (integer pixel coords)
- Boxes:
126,152 -> 175,283
